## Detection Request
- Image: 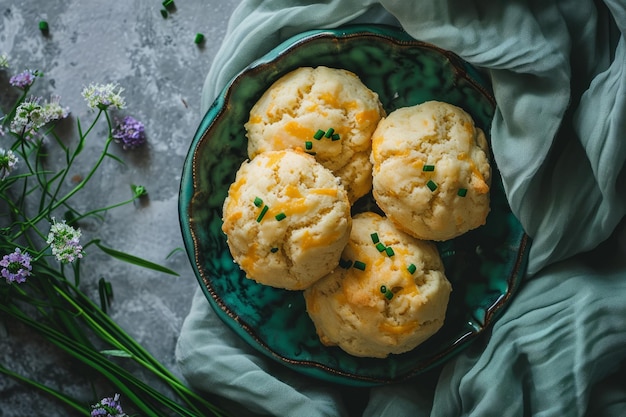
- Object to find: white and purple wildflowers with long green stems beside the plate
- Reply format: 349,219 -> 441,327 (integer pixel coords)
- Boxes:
0,56 -> 226,416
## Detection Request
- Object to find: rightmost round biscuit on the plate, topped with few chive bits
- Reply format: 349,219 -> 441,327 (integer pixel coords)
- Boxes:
371,101 -> 491,241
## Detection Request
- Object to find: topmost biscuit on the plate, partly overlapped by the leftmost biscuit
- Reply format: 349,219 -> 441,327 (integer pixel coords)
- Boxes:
245,66 -> 384,202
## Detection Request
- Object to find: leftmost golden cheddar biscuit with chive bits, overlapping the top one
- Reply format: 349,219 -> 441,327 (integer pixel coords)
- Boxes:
222,150 -> 352,290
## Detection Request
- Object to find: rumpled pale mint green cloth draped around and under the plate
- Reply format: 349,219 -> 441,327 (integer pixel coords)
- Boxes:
176,0 -> 626,417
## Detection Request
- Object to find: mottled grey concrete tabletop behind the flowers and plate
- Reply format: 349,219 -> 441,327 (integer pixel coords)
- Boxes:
0,0 -> 239,417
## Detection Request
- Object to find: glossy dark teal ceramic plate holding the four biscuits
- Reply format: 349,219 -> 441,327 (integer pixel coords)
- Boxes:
179,25 -> 529,386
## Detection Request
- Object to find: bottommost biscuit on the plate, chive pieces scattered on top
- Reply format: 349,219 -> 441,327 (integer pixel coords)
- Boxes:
304,212 -> 451,358
